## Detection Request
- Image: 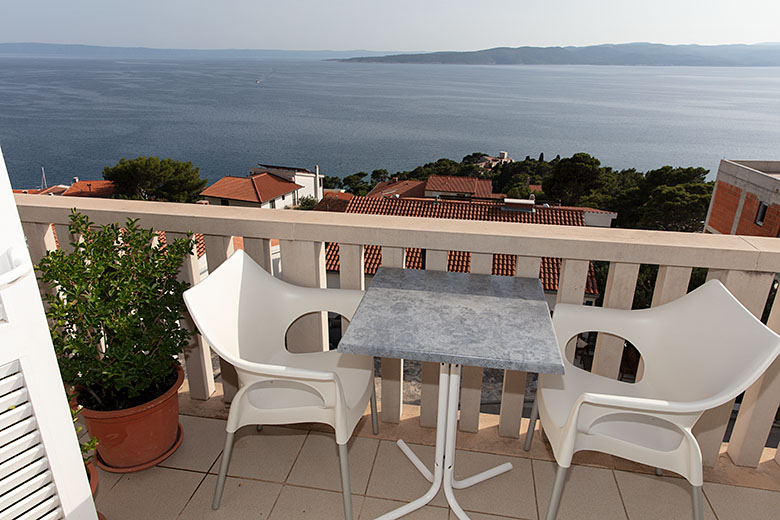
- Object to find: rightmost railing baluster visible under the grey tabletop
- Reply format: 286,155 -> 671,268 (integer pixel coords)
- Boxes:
498,256 -> 540,439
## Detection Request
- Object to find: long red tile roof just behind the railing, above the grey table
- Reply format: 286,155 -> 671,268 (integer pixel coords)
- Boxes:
315,197 -> 598,295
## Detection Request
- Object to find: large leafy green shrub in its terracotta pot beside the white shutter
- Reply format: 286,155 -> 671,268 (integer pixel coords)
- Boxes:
37,210 -> 193,472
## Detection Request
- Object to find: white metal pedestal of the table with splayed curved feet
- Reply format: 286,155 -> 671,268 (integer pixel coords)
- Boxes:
377,363 -> 512,520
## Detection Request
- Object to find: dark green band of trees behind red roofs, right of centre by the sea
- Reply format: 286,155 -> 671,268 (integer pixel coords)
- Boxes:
324,152 -> 713,232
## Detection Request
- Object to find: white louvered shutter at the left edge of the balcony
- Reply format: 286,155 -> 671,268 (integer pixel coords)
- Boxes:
0,150 -> 97,520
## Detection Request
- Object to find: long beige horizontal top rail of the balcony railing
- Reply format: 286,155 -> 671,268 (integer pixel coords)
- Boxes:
16,194 -> 780,272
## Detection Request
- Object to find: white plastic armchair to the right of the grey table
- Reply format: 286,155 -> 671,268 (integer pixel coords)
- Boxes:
525,280 -> 780,520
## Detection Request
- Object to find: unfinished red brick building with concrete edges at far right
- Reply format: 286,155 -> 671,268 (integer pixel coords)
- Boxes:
704,159 -> 780,237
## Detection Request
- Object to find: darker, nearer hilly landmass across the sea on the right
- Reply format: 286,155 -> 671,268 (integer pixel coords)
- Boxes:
339,43 -> 780,67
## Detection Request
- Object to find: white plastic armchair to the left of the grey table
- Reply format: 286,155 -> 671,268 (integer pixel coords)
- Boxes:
184,250 -> 378,520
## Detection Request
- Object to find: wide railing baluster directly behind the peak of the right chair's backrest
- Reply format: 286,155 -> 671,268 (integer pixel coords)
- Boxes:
693,269 -> 774,467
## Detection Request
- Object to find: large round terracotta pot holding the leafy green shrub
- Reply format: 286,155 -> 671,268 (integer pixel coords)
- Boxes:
81,367 -> 184,473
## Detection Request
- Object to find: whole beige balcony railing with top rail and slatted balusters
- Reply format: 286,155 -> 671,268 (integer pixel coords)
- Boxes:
16,195 -> 780,467
